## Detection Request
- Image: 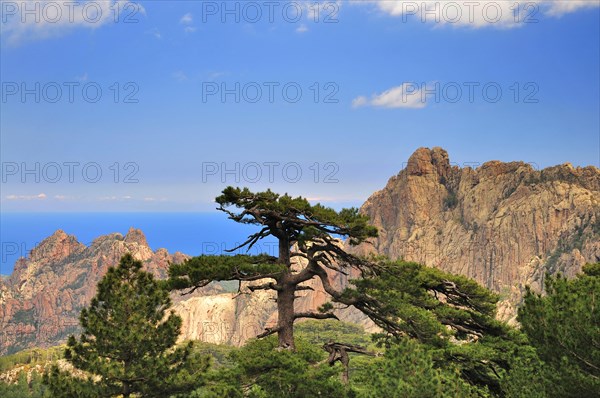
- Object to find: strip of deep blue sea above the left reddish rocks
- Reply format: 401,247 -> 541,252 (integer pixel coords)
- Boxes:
0,212 -> 276,275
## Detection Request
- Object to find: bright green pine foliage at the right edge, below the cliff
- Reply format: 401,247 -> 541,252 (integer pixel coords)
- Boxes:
518,263 -> 600,397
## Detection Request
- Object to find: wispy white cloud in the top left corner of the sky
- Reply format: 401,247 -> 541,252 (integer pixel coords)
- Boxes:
0,0 -> 146,46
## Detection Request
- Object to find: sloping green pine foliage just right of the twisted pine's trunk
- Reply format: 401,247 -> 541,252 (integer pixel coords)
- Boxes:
344,259 -> 534,396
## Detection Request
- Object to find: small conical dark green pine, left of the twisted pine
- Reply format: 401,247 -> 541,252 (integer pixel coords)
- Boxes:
44,254 -> 209,397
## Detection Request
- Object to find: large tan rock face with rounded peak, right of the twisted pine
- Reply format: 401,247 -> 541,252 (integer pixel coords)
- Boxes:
357,148 -> 600,320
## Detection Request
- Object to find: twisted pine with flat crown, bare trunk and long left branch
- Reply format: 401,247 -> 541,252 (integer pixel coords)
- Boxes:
169,187 -> 377,350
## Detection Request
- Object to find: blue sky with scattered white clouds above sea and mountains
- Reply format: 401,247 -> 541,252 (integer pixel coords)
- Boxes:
0,0 -> 600,212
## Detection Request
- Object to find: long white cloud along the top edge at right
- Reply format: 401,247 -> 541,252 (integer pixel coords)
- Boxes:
376,0 -> 600,28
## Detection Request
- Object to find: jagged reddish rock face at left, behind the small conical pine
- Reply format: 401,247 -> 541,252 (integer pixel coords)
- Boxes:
0,229 -> 192,354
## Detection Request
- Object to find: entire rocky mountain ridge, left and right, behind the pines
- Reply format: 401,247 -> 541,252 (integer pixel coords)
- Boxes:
0,147 -> 600,355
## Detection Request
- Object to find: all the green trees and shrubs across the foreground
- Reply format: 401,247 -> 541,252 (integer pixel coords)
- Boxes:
0,189 -> 600,398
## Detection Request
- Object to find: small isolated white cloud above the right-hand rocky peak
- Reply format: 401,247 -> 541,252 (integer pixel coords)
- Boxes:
352,83 -> 427,109
